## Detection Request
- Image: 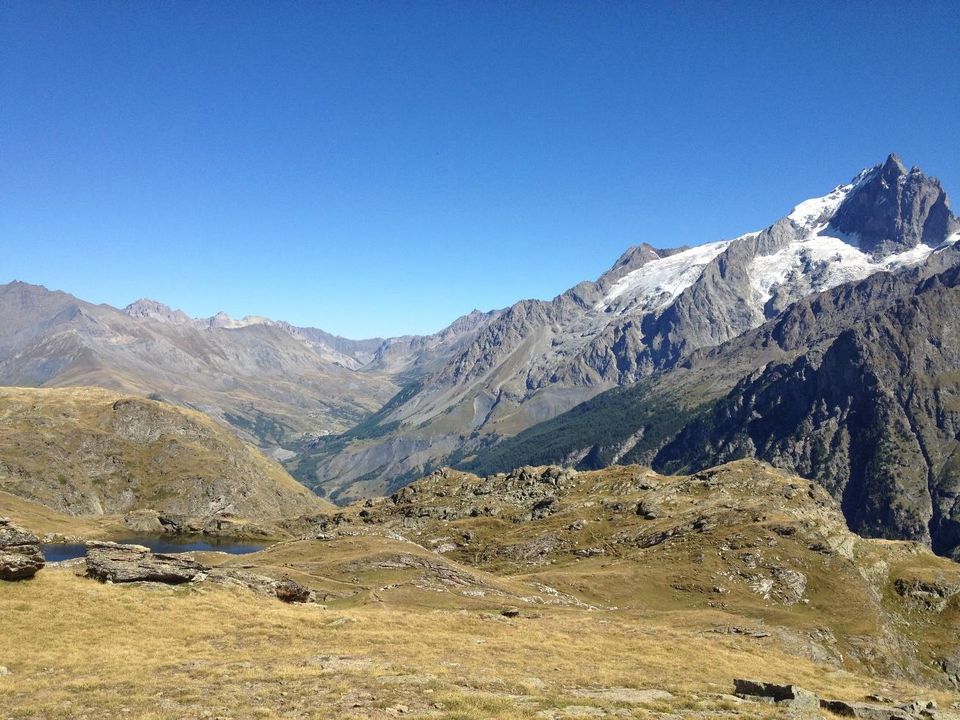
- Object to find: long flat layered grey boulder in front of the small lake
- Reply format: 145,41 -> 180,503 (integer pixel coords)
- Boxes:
86,541 -> 207,585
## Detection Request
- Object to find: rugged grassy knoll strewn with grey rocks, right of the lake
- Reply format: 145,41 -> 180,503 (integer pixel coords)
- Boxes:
327,460 -> 960,682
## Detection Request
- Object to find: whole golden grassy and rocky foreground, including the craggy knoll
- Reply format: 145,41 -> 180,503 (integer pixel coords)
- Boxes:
0,462 -> 960,719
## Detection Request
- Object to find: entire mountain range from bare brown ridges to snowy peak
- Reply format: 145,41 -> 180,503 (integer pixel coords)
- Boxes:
0,155 -> 960,554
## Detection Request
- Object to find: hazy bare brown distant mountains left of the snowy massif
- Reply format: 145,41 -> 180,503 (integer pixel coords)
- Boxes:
0,282 -> 496,459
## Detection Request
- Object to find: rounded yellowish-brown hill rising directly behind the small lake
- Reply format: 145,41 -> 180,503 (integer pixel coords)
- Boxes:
0,388 -> 328,527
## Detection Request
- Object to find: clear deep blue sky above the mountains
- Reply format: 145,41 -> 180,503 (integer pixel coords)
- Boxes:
0,0 -> 960,337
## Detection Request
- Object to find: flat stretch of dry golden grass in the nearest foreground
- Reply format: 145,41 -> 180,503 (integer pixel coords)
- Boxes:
0,569 -> 952,720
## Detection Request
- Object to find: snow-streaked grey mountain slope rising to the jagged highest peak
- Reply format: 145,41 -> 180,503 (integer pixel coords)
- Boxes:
295,156 -> 960,497
